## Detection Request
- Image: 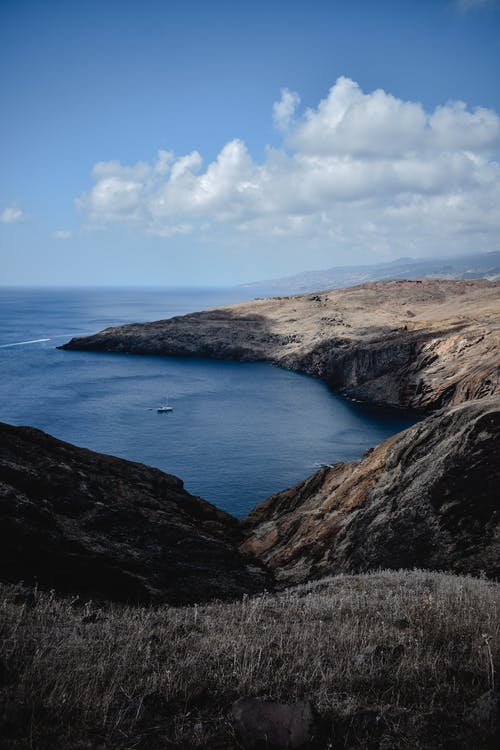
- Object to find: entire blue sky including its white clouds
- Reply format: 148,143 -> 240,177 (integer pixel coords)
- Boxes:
0,0 -> 500,285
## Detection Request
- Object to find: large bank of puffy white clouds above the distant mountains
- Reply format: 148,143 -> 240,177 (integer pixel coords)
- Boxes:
77,77 -> 500,255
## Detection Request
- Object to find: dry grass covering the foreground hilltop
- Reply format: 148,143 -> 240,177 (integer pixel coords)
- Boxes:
0,571 -> 500,750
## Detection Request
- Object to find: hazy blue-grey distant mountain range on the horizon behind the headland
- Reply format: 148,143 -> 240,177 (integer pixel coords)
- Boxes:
242,251 -> 500,294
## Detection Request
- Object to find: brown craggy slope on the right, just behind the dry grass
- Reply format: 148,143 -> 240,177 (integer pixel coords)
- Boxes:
241,396 -> 500,583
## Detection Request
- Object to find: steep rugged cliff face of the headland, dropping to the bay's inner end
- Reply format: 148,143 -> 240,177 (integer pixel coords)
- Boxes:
297,321 -> 500,410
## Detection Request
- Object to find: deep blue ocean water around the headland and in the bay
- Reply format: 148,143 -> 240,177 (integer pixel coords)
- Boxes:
0,288 -> 416,516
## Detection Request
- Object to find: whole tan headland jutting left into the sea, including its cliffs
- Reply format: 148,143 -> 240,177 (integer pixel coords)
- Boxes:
62,280 -> 500,409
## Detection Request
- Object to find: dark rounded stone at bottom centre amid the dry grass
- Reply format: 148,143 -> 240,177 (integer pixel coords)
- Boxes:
232,698 -> 318,750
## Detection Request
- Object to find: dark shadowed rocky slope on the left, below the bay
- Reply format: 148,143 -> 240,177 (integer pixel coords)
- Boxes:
0,424 -> 272,604
